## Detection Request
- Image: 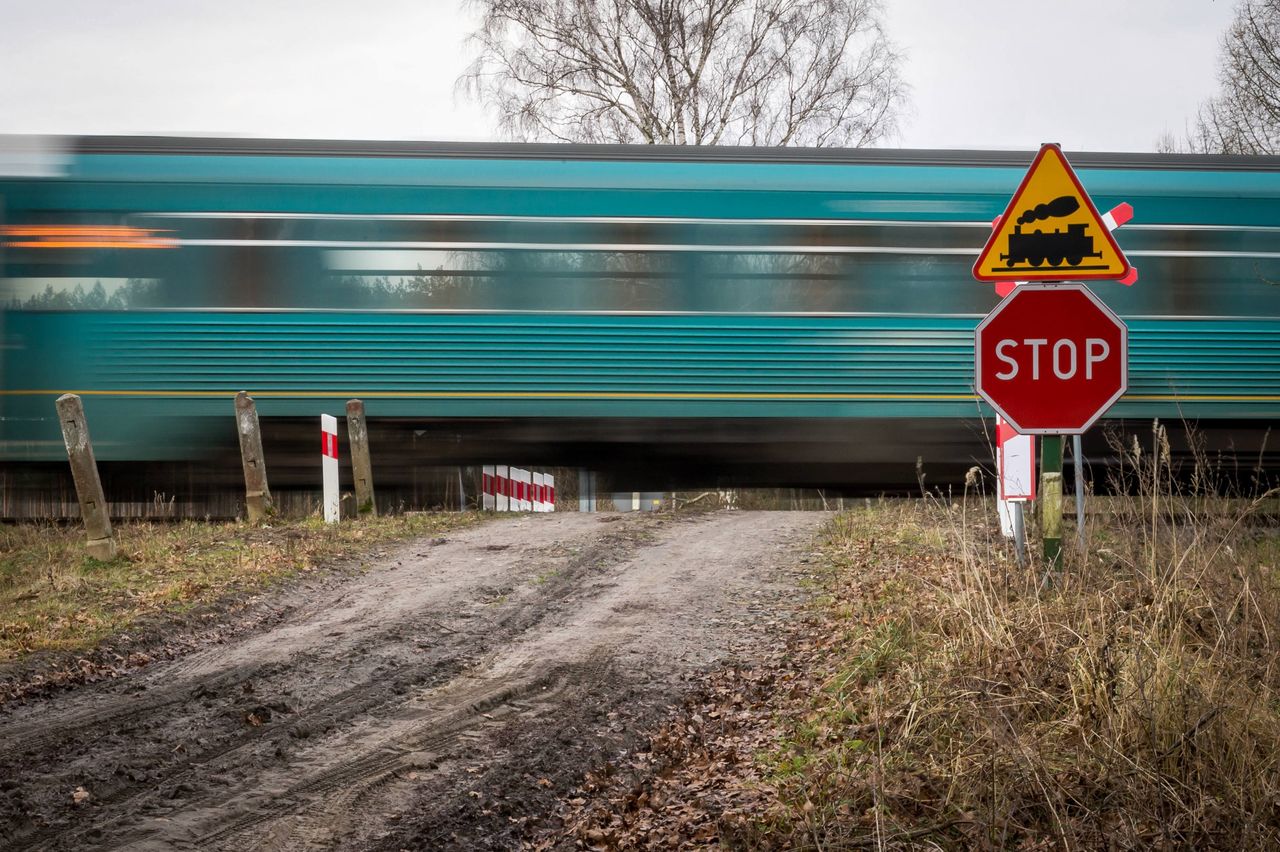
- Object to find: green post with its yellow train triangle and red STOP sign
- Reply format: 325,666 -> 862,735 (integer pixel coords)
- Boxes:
973,143 -> 1137,568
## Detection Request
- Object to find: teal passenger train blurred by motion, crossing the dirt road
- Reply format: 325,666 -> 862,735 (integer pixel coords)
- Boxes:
0,137 -> 1280,514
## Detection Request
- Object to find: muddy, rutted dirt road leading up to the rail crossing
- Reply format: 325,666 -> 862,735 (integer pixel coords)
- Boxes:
0,512 -> 824,849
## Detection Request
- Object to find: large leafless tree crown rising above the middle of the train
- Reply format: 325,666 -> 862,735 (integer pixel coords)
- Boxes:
460,0 -> 905,146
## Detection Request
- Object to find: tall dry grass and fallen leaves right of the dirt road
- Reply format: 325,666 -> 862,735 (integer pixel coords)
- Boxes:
754,432 -> 1280,849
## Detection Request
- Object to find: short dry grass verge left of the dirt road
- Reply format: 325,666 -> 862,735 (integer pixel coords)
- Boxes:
0,513 -> 483,663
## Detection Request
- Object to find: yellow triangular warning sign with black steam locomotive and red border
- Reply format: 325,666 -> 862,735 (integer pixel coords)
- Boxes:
973,145 -> 1129,281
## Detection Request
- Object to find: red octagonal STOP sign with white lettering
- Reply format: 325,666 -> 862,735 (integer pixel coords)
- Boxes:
974,284 -> 1129,435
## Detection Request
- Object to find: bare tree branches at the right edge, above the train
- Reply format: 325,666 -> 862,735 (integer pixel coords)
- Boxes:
1171,0 -> 1280,154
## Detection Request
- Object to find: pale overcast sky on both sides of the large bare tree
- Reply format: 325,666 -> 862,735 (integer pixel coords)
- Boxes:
0,0 -> 1234,151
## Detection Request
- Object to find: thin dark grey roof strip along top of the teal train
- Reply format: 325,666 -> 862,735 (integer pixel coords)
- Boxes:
60,136 -> 1280,171
